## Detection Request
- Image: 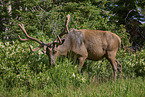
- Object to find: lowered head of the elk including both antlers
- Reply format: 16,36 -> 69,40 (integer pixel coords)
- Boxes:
18,14 -> 70,65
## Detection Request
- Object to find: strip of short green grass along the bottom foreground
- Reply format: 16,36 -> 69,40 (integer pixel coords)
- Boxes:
0,77 -> 145,97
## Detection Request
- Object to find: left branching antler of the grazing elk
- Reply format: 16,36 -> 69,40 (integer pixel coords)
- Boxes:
18,24 -> 47,52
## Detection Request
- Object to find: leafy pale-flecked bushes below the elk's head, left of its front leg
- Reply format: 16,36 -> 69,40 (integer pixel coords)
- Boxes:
0,41 -> 86,88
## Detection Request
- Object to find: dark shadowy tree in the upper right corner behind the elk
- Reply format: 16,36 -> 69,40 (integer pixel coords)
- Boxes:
106,0 -> 145,50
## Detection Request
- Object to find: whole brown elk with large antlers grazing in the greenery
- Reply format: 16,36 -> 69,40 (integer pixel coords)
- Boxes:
18,15 -> 121,81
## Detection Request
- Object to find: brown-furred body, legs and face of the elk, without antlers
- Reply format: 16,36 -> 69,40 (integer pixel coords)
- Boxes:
46,29 -> 121,81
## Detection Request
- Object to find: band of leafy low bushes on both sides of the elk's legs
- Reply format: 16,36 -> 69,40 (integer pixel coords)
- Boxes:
0,41 -> 145,89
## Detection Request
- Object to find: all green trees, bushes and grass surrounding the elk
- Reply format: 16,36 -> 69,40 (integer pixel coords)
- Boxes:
0,0 -> 145,97
